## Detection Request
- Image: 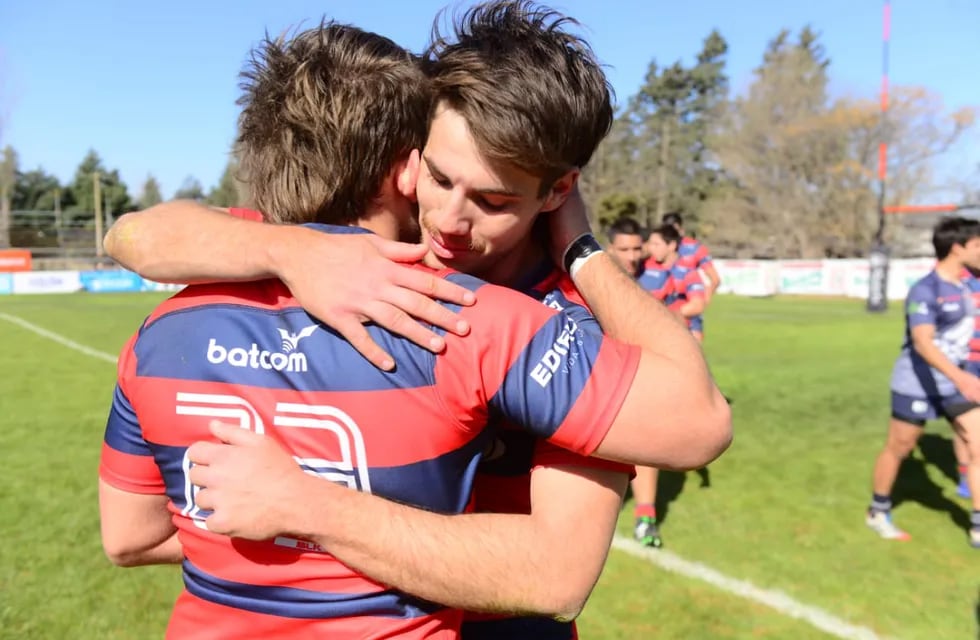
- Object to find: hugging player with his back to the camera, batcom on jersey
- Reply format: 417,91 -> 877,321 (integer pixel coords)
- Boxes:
100,23 -> 648,639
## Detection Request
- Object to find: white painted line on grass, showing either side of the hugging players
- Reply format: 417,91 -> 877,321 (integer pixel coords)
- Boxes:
0,312 -> 884,640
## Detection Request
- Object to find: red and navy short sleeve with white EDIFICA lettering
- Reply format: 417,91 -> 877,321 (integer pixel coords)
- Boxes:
436,285 -> 640,455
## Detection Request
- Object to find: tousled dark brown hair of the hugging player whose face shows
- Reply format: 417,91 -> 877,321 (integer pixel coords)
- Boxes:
423,0 -> 613,194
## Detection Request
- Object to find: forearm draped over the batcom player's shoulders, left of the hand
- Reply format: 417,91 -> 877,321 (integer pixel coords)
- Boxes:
105,200 -> 281,283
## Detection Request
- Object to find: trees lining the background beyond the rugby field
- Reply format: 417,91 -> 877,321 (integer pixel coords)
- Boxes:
0,27 -> 980,258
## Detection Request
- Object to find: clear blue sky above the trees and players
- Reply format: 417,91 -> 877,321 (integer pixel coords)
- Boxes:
0,0 -> 980,197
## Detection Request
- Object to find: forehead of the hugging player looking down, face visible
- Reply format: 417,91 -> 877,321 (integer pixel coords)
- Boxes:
422,103 -> 540,196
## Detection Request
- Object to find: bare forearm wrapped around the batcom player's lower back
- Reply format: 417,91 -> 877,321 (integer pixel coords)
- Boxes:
290,477 -> 580,616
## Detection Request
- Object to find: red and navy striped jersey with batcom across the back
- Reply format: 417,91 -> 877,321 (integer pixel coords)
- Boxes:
100,222 -> 639,639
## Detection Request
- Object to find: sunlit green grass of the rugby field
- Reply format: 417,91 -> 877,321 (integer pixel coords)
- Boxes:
0,294 -> 980,640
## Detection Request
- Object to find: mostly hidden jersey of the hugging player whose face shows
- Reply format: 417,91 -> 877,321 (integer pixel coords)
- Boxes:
462,261 -> 633,640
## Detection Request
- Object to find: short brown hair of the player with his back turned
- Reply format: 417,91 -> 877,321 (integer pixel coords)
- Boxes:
235,22 -> 431,224
